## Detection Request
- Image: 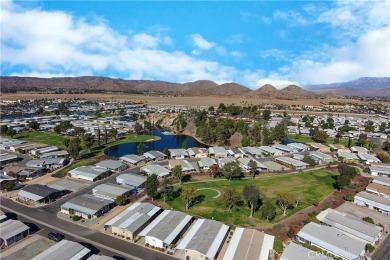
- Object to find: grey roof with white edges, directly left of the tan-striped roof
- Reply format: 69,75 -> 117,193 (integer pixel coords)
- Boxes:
177,219 -> 230,259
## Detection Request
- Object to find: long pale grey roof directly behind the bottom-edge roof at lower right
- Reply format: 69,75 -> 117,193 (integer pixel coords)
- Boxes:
297,222 -> 366,259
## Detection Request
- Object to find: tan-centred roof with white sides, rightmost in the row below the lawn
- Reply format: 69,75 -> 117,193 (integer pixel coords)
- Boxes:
223,228 -> 275,260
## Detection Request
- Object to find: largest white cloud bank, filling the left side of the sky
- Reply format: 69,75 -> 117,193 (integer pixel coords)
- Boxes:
0,4 -> 242,82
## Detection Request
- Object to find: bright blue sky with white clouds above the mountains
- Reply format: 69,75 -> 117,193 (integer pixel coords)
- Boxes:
0,0 -> 390,89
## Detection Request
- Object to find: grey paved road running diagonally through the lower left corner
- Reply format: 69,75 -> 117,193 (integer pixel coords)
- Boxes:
0,198 -> 176,260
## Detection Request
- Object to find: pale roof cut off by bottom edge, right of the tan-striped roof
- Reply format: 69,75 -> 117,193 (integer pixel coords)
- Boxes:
280,242 -> 333,260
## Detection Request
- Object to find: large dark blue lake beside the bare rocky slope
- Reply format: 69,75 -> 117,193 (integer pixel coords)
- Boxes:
104,130 -> 209,157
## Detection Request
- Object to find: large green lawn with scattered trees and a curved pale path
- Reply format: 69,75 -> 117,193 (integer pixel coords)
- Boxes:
159,170 -> 334,226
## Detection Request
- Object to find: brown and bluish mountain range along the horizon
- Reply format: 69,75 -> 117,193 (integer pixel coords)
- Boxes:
0,76 -> 390,99
